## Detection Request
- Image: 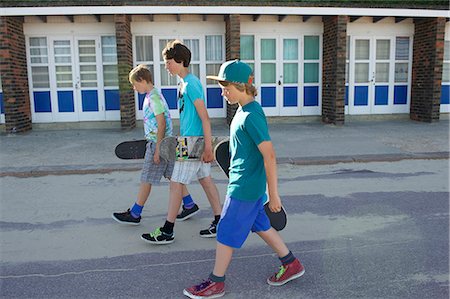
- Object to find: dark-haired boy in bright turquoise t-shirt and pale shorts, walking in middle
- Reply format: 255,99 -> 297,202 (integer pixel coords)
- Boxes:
142,40 -> 222,244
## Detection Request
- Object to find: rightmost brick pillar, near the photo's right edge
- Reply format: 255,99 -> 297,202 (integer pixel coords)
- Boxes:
410,18 -> 445,122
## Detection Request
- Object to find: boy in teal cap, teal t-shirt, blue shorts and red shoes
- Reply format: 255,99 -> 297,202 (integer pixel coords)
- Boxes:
183,60 -> 305,298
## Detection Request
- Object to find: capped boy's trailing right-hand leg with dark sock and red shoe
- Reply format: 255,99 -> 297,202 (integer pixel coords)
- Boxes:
257,228 -> 305,286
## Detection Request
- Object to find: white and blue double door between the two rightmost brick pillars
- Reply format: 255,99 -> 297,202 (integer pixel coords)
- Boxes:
346,36 -> 411,114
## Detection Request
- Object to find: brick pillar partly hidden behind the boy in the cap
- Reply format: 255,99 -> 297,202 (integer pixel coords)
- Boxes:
225,15 -> 241,125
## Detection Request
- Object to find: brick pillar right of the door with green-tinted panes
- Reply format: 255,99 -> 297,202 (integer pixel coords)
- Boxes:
322,16 -> 348,125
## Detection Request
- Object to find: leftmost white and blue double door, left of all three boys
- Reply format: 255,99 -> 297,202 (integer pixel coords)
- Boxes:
29,36 -> 107,122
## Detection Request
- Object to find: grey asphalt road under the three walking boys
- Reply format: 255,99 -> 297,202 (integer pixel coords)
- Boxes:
0,159 -> 449,298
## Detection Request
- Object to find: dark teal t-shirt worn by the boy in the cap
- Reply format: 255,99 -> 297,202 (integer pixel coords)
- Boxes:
227,101 -> 270,201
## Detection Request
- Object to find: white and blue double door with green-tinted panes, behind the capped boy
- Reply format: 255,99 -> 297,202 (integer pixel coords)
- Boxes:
246,35 -> 321,116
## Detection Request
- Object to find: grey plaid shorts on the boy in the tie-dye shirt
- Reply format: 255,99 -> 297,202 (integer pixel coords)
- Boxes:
141,141 -> 174,184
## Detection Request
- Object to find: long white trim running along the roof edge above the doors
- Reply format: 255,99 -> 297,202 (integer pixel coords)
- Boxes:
0,6 -> 450,18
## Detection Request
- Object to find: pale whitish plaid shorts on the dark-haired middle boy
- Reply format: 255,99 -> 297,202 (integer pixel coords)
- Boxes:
172,161 -> 211,185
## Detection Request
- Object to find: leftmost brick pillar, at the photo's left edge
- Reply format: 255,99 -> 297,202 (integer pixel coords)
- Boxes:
0,17 -> 32,133
